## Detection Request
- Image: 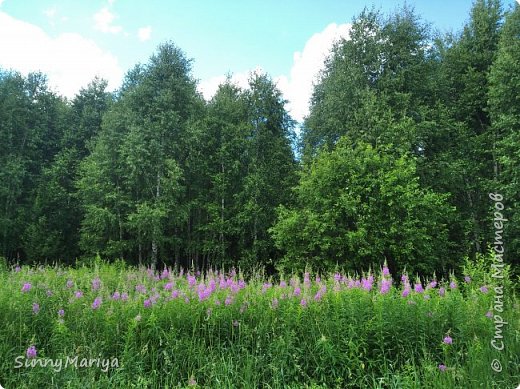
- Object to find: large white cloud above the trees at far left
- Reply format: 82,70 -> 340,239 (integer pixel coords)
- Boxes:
0,12 -> 123,98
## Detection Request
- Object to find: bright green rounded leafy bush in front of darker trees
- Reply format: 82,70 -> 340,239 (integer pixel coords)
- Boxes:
271,138 -> 452,273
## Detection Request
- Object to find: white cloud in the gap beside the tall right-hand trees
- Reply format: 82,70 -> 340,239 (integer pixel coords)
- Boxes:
276,23 -> 351,122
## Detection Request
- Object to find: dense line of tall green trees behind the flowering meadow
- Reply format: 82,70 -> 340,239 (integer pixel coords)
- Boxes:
0,0 -> 520,273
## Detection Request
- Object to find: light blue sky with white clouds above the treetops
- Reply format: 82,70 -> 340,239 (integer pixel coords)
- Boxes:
0,0 -> 512,120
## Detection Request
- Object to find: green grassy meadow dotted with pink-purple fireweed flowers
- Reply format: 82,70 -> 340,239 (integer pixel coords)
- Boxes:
0,258 -> 520,389
